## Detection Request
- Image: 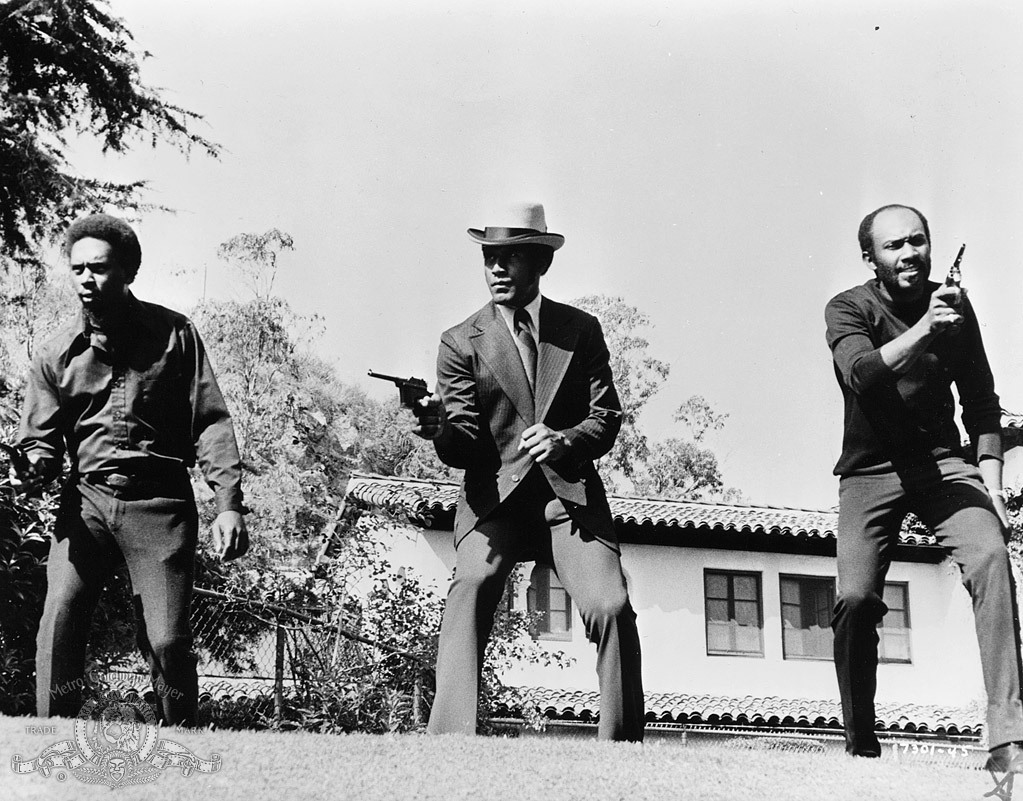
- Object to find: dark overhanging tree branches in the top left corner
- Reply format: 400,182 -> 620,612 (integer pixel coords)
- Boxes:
0,0 -> 219,270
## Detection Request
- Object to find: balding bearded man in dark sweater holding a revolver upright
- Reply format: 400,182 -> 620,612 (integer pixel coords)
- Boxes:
825,205 -> 1023,770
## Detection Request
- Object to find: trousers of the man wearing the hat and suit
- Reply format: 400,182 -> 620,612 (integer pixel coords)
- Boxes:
429,470 -> 643,741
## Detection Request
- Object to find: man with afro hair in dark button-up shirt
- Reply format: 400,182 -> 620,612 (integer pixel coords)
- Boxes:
14,214 -> 249,725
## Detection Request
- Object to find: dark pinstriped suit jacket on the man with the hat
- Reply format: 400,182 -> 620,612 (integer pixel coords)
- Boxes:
435,298 -> 622,549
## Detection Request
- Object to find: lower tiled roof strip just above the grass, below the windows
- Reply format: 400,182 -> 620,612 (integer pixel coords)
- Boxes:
498,687 -> 984,738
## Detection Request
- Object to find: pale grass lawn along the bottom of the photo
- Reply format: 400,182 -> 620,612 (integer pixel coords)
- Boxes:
0,718 -> 1006,801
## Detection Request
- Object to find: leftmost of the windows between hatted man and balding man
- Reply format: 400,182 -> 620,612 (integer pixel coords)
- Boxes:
704,570 -> 764,656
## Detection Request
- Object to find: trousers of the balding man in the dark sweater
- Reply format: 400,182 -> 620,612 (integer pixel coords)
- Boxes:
832,458 -> 1023,756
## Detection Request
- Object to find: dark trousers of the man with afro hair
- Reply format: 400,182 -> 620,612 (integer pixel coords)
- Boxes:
36,473 -> 198,725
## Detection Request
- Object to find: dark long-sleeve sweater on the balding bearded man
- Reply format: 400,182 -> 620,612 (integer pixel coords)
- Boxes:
825,279 -> 1000,476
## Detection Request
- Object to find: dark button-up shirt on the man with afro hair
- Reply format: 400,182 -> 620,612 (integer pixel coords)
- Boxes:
20,296 -> 243,511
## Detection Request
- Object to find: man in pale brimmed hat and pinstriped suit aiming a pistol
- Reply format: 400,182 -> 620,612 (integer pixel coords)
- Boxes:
415,204 -> 643,741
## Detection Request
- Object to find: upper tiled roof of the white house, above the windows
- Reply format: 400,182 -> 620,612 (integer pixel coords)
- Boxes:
347,473 -> 935,546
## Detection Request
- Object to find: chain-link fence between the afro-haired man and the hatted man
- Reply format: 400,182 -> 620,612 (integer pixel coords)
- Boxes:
103,587 -> 432,730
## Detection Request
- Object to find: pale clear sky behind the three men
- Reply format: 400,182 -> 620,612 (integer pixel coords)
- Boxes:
68,0 -> 1023,507
